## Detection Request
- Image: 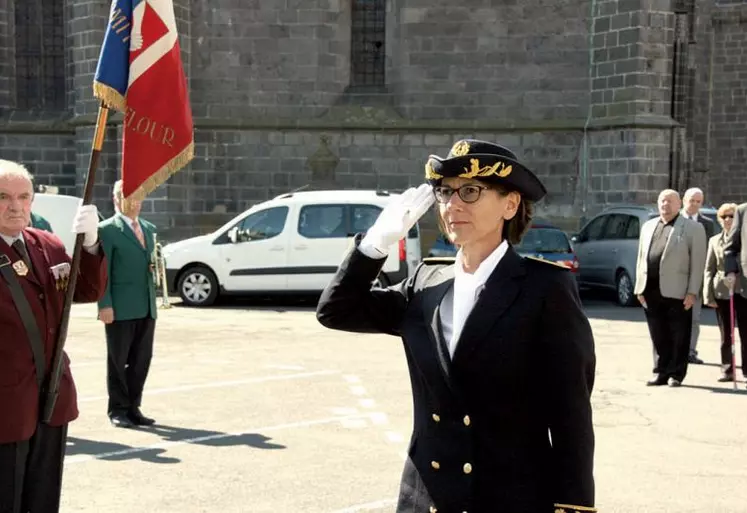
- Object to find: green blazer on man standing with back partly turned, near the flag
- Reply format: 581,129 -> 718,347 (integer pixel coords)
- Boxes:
99,214 -> 158,321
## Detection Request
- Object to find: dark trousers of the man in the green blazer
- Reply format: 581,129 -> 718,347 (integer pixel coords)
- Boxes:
105,317 -> 156,417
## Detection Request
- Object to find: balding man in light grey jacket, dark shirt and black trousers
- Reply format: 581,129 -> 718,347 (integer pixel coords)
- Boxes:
635,189 -> 707,387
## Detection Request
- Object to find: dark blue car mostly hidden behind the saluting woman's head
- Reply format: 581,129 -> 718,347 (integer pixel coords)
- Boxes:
428,223 -> 578,273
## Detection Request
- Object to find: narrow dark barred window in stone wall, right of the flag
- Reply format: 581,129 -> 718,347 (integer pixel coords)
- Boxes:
350,0 -> 386,86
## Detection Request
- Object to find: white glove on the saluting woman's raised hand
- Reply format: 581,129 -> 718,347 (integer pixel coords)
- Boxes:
359,183 -> 435,257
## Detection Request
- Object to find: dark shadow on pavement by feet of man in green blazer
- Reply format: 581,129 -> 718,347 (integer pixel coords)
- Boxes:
66,424 -> 286,464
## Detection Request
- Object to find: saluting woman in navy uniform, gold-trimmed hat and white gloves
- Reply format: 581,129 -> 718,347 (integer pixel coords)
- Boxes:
317,140 -> 596,513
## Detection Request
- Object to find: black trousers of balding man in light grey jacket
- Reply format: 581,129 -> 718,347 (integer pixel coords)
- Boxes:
643,277 -> 693,381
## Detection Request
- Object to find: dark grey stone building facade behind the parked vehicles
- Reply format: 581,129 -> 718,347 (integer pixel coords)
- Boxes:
0,0 -> 747,240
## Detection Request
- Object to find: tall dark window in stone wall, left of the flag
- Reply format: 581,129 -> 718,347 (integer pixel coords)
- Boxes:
15,0 -> 66,110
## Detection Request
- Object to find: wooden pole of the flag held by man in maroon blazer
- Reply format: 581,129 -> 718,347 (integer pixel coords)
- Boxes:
41,101 -> 109,424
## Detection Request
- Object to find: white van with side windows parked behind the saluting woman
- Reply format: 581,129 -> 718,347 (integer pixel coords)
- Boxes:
163,191 -> 421,306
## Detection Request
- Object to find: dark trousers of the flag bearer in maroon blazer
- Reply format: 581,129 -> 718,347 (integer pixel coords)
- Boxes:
0,424 -> 67,513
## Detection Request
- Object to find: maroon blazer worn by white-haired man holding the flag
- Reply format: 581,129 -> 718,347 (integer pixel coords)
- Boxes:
0,228 -> 107,444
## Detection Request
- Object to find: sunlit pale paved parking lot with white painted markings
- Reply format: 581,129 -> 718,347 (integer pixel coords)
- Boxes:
63,299 -> 747,513
